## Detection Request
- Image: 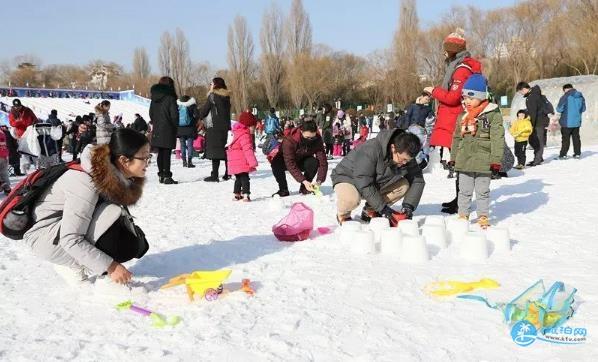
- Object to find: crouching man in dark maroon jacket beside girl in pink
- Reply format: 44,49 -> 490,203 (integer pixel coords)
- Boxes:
271,120 -> 328,197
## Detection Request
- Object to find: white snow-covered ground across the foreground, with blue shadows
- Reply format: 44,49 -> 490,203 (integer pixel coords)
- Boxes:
0,146 -> 598,361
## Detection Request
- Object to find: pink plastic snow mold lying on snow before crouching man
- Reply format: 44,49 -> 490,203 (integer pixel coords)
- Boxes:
272,202 -> 314,241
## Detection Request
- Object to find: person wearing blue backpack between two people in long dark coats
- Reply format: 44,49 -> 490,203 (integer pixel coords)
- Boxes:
176,96 -> 197,168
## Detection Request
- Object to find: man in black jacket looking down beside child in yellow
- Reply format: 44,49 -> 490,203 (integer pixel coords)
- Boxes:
516,82 -> 549,167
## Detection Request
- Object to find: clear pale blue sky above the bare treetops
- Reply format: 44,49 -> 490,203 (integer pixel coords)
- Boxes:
0,0 -> 516,71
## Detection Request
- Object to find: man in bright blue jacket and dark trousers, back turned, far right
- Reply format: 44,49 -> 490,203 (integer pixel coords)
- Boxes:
556,84 -> 586,160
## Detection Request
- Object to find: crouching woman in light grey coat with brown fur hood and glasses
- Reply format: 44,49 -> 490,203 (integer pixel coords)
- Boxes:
24,129 -> 151,283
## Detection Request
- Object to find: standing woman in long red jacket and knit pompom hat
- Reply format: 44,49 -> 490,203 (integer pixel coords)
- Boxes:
424,29 -> 482,214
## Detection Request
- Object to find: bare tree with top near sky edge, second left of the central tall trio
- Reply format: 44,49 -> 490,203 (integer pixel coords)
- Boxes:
260,3 -> 284,107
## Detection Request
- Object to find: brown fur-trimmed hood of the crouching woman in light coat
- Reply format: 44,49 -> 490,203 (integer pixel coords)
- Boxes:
81,145 -> 145,206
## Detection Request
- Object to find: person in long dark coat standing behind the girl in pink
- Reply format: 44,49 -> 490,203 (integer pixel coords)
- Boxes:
199,78 -> 231,182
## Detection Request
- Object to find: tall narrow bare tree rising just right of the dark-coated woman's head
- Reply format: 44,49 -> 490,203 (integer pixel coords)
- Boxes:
227,16 -> 254,113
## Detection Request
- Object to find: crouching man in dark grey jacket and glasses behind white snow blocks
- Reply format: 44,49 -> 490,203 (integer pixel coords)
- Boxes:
332,129 -> 426,226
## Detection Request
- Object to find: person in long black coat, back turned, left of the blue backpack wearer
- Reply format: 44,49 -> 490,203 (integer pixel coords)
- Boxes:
149,77 -> 179,185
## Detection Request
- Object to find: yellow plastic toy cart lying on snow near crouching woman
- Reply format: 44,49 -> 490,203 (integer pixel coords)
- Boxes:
160,269 -> 232,302
